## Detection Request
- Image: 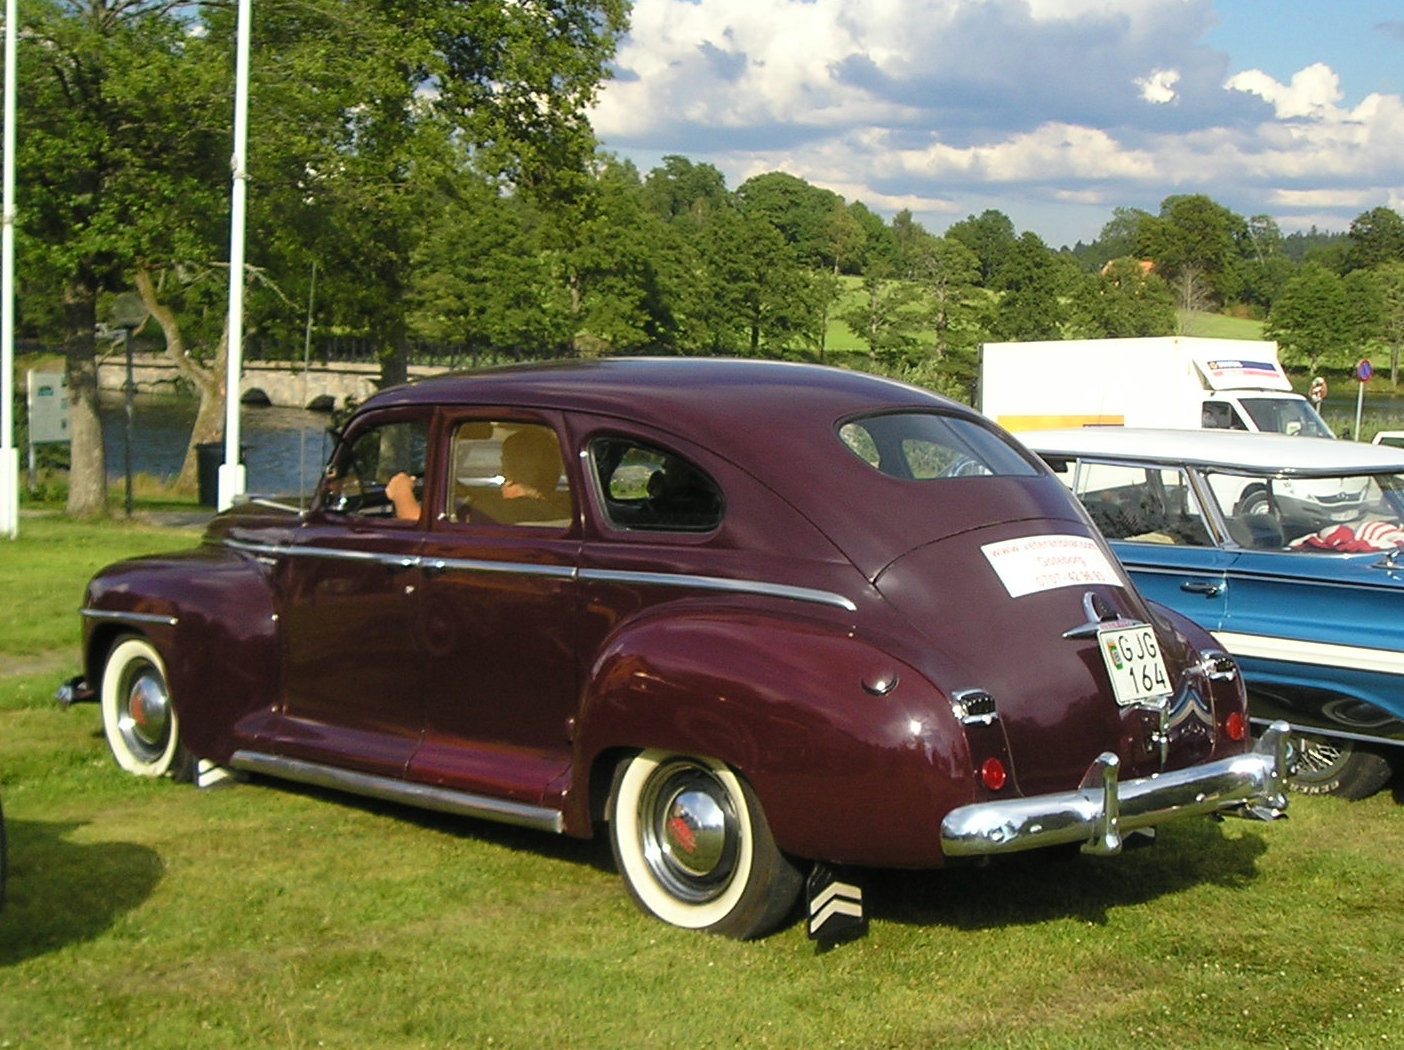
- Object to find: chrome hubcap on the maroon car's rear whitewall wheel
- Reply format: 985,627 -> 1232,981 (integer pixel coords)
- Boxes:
639,762 -> 737,903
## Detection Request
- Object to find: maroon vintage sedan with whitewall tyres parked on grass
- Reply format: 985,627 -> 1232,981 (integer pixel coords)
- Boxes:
72,359 -> 1286,936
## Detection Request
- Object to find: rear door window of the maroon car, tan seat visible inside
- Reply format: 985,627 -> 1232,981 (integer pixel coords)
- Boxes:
449,420 -> 571,528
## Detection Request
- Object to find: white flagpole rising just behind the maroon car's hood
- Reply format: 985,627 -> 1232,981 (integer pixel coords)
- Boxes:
219,0 -> 253,511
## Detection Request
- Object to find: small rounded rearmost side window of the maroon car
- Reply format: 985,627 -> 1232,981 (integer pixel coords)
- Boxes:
590,438 -> 724,532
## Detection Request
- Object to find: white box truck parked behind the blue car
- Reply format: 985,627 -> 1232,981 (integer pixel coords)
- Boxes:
979,335 -> 1334,438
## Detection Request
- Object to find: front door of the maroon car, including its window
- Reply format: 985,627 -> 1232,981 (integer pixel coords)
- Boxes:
270,410 -> 430,776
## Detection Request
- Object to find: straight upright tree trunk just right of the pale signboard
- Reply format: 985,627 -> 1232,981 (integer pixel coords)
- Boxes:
63,277 -> 107,519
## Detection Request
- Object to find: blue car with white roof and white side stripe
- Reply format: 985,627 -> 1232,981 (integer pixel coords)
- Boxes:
1016,427 -> 1404,799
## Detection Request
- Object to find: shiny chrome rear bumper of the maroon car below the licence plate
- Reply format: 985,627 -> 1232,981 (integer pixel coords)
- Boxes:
941,722 -> 1292,856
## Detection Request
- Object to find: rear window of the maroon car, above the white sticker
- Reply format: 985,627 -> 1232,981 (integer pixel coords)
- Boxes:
838,413 -> 1039,481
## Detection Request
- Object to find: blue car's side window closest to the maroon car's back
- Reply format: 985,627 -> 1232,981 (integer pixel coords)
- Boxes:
1073,462 -> 1210,547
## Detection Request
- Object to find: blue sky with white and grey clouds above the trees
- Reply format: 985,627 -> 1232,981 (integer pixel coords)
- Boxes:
594,0 -> 1404,247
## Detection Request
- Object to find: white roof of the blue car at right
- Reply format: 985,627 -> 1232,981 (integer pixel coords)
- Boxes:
1014,427 -> 1404,474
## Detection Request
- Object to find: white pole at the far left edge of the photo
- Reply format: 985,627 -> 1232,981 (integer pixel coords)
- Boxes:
0,0 -> 20,539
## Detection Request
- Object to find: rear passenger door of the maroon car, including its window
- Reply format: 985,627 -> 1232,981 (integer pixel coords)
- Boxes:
410,408 -> 580,806
